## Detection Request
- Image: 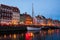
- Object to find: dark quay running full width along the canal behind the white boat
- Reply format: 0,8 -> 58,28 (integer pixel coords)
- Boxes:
0,25 -> 60,34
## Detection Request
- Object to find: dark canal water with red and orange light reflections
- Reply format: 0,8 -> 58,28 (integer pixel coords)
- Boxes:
0,29 -> 60,40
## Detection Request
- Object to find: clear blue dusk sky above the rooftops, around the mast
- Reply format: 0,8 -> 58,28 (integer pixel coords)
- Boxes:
0,0 -> 60,20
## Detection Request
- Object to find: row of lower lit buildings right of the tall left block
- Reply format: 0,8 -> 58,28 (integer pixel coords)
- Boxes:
20,12 -> 60,26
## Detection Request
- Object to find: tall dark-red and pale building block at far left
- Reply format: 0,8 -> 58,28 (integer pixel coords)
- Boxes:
0,4 -> 20,24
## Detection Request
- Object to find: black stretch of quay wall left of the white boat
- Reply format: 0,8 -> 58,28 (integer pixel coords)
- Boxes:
0,26 -> 27,34
